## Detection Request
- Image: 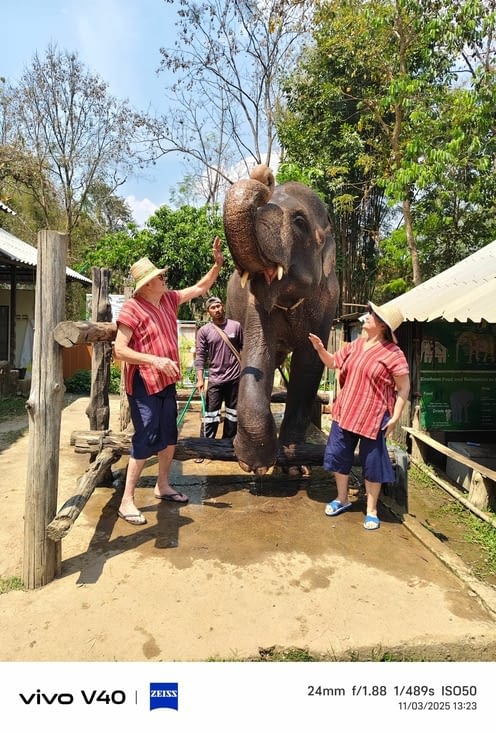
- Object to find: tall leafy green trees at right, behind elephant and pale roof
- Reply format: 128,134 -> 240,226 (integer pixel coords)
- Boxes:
278,0 -> 496,302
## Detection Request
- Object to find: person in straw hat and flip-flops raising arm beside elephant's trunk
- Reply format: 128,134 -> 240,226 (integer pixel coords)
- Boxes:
114,237 -> 224,525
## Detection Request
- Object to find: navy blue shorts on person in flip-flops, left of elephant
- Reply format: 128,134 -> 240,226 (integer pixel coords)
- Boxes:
127,370 -> 177,460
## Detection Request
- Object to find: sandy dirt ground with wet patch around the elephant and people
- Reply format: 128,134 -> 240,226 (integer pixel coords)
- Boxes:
0,397 -> 496,661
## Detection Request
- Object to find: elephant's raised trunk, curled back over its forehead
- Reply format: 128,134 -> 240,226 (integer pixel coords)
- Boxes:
224,165 -> 275,275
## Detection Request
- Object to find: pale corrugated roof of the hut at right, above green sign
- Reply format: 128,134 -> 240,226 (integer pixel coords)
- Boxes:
388,241 -> 496,323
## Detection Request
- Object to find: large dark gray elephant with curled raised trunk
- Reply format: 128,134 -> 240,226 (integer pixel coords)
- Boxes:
224,165 -> 339,475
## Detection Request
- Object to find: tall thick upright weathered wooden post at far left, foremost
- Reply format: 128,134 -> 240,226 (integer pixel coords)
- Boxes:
23,231 -> 68,590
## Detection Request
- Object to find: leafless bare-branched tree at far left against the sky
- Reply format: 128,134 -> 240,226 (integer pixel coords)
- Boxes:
0,45 -> 153,258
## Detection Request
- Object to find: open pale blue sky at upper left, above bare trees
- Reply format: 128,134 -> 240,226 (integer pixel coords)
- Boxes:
0,0 -> 184,223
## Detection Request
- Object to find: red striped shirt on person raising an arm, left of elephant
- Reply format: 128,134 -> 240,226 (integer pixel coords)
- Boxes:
117,290 -> 180,394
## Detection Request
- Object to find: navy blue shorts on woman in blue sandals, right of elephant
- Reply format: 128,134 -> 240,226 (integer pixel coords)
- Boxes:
324,415 -> 396,484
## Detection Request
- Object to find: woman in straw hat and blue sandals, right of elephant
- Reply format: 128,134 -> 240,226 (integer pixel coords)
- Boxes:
309,302 -> 410,530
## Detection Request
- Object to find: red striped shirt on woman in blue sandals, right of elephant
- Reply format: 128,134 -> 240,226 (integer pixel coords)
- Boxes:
332,337 -> 409,439
